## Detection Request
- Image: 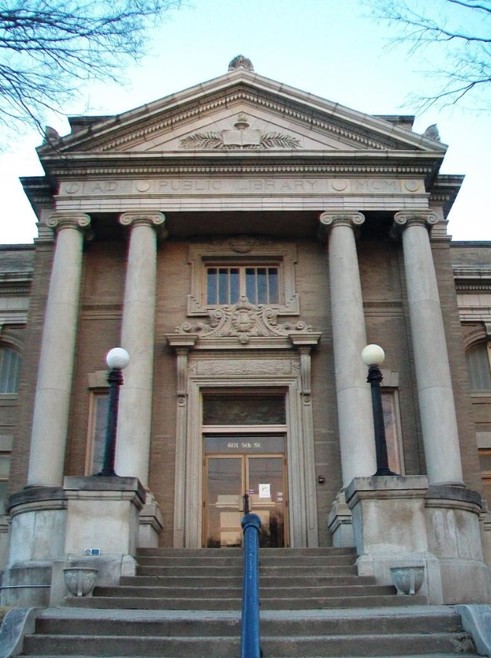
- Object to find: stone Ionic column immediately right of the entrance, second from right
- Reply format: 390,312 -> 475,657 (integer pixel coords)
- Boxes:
320,211 -> 377,487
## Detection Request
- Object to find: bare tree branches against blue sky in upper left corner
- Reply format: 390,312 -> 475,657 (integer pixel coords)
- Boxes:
0,0 -> 181,135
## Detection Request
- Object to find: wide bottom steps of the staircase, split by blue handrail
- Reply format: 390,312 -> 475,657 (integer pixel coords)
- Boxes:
23,606 -> 476,658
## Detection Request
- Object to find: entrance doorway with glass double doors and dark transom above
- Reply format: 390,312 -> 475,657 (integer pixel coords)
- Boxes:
201,388 -> 289,548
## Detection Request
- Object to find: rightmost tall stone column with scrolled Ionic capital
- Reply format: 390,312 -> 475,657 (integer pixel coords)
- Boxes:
395,210 -> 463,485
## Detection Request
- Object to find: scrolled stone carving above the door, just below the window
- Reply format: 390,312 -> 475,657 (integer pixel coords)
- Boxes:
176,297 -> 312,345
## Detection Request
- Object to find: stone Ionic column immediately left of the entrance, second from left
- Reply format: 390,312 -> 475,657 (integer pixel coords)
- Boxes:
115,212 -> 165,485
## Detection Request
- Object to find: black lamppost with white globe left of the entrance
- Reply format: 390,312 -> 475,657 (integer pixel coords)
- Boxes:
97,347 -> 130,476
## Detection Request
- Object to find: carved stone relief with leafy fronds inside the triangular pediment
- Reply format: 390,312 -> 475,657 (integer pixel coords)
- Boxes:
181,113 -> 300,151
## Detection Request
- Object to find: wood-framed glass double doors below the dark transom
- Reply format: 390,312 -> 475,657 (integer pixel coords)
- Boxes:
203,442 -> 288,548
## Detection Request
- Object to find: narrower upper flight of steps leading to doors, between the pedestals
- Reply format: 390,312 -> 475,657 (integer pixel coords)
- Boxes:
67,548 -> 426,610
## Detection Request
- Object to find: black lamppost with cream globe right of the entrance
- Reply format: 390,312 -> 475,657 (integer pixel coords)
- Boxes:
361,345 -> 399,475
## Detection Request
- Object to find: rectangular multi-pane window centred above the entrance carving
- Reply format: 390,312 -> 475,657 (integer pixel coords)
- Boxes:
206,265 -> 279,306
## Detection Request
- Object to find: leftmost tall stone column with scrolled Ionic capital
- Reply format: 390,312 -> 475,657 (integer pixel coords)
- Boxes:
27,212 -> 90,486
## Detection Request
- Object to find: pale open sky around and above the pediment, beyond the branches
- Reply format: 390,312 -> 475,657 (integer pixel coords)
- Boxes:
0,0 -> 491,243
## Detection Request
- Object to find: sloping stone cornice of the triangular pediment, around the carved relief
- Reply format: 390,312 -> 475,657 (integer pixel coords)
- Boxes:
38,72 -> 446,160
